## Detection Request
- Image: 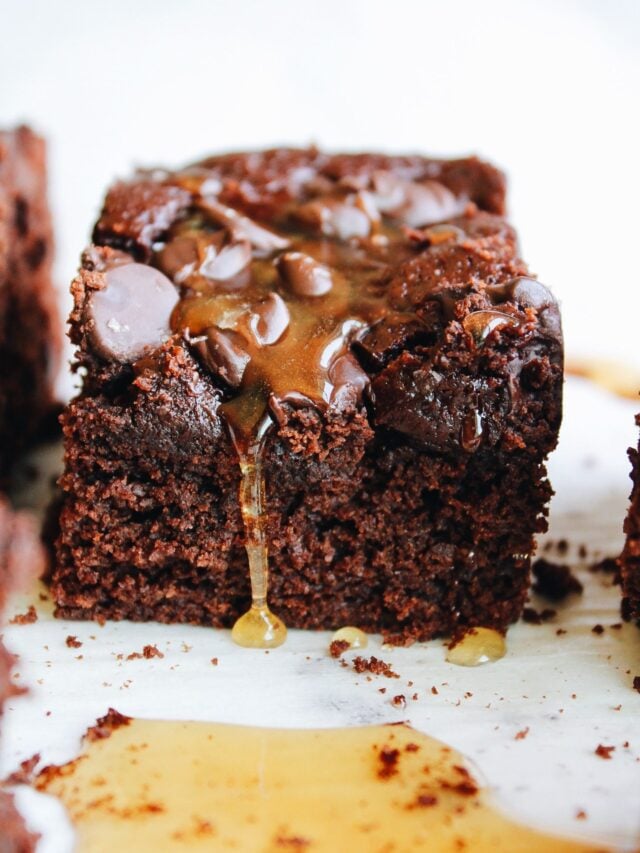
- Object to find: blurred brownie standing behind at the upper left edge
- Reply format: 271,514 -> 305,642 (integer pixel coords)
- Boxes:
0,127 -> 61,481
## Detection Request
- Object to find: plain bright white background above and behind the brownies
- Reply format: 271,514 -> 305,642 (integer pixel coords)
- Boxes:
0,0 -> 640,368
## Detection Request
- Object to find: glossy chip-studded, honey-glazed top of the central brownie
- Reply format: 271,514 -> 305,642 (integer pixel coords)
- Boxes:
72,149 -> 555,452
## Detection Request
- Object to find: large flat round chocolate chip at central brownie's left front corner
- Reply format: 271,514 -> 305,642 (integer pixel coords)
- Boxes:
85,263 -> 179,363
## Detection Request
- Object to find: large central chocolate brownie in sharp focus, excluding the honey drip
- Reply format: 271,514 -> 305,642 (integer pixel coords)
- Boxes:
52,150 -> 562,642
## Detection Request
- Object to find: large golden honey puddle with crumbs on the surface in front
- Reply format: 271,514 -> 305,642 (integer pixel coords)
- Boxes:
35,712 -> 596,853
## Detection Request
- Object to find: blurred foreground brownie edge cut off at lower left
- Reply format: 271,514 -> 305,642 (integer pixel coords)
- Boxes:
0,497 -> 44,853
